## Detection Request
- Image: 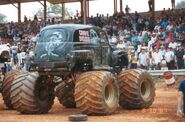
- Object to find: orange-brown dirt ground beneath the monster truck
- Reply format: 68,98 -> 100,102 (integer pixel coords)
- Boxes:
0,83 -> 185,122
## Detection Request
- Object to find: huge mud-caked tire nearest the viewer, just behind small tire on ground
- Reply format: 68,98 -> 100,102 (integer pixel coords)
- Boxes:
75,71 -> 119,115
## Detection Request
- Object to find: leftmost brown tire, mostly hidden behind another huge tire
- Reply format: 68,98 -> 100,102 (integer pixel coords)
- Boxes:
2,70 -> 23,109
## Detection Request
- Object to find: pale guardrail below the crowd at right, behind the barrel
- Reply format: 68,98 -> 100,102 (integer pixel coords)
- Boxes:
147,69 -> 185,76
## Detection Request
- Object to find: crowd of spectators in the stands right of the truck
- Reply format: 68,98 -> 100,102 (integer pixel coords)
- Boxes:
89,9 -> 185,69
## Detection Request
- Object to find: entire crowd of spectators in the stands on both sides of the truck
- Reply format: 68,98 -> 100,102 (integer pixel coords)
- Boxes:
0,6 -> 185,71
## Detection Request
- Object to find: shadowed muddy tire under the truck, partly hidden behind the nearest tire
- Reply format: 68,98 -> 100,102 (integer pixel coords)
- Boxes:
55,79 -> 76,108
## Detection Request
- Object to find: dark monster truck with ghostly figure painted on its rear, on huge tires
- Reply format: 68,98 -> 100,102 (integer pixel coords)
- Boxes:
7,24 -> 155,115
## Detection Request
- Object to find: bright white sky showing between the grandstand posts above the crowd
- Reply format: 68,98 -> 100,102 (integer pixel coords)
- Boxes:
0,0 -> 182,22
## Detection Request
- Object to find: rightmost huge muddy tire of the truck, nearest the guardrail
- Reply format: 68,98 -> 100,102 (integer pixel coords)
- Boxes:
118,69 -> 155,109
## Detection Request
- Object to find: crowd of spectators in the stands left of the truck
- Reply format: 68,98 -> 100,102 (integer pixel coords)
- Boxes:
0,17 -> 40,72
